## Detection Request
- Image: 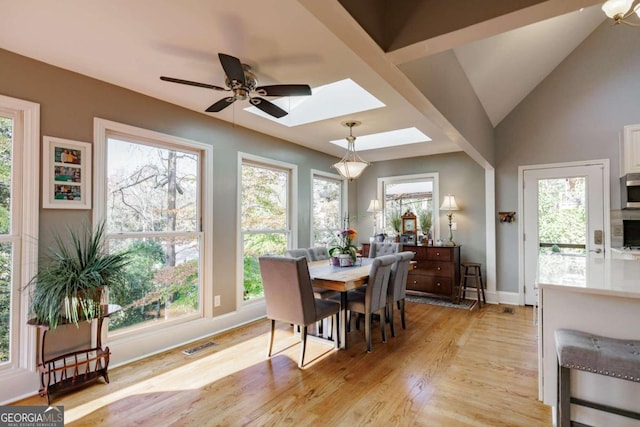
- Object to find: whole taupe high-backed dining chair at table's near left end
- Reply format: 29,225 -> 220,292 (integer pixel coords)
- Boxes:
259,256 -> 340,368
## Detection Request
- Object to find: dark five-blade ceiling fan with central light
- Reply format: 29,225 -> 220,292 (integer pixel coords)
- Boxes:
160,53 -> 311,119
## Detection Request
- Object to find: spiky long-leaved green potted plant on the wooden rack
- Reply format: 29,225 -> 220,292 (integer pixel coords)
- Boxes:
28,223 -> 129,329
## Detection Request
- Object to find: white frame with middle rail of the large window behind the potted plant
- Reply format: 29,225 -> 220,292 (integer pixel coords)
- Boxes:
93,118 -> 214,338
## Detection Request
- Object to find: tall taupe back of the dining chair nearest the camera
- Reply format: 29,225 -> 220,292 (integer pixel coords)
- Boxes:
259,256 -> 316,325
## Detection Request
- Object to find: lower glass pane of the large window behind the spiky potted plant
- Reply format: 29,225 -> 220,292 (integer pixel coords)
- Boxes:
109,236 -> 200,331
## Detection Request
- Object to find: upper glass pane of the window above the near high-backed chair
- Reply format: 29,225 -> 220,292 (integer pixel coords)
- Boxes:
241,164 -> 289,231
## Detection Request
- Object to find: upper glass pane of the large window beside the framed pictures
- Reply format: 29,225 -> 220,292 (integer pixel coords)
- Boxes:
107,138 -> 199,233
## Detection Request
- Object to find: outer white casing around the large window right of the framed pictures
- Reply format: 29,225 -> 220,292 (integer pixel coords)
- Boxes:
93,117 -> 213,324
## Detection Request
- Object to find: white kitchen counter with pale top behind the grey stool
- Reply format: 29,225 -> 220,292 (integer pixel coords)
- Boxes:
537,254 -> 640,426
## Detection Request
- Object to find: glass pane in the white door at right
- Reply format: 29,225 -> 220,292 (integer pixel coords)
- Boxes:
538,177 -> 587,255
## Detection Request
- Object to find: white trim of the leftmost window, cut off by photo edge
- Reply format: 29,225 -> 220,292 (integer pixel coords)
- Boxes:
0,95 -> 40,404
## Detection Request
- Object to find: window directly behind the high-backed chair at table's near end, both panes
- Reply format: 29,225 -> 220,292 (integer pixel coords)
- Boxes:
240,156 -> 294,300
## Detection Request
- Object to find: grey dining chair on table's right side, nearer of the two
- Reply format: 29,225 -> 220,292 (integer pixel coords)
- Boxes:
347,255 -> 396,353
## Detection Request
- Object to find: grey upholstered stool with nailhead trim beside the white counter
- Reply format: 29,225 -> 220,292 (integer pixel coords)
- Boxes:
554,329 -> 640,427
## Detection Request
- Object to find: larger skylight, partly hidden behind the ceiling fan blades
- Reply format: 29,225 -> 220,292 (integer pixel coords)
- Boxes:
245,79 -> 385,127
